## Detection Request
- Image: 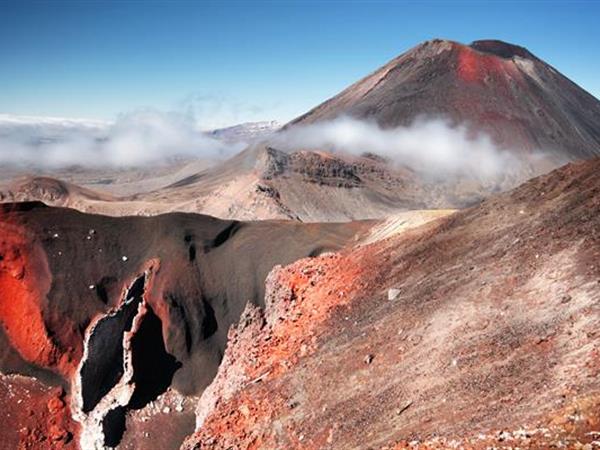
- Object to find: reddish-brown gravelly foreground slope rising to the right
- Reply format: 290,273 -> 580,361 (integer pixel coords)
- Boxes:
184,159 -> 600,450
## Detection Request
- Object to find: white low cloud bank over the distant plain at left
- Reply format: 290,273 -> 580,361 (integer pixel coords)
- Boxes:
0,110 -> 244,168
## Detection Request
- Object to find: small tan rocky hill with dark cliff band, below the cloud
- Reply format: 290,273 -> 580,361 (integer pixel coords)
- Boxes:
136,144 -> 474,222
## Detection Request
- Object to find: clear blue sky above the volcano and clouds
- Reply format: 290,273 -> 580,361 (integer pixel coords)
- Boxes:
0,0 -> 600,127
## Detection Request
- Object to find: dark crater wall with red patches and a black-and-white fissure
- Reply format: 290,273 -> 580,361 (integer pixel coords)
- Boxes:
0,203 -> 372,449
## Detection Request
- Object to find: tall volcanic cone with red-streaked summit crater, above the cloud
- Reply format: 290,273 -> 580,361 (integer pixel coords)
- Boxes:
287,39 -> 600,160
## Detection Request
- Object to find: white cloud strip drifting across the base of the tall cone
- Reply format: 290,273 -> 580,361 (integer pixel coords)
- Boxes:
271,117 -> 518,178
